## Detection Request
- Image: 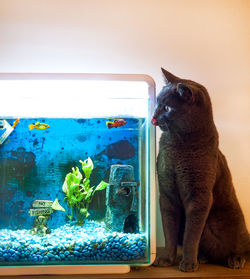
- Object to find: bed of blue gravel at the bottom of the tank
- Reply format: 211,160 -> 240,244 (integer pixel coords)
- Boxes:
0,221 -> 147,265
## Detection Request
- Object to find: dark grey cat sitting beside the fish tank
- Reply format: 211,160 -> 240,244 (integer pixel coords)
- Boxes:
152,69 -> 250,271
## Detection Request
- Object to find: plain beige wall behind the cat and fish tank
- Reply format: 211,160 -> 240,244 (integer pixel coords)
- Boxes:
0,0 -> 250,245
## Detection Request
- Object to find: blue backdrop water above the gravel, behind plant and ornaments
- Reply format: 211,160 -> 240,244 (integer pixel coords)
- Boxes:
0,118 -> 145,229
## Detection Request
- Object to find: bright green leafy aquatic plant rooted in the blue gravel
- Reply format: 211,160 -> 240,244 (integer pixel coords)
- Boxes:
62,158 -> 108,225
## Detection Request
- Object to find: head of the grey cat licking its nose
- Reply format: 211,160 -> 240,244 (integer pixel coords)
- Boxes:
151,68 -> 212,133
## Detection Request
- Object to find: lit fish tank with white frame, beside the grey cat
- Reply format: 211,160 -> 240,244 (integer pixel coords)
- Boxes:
0,73 -> 156,275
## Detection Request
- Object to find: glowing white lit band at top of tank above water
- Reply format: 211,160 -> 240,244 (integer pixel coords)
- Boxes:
0,74 -> 154,118
